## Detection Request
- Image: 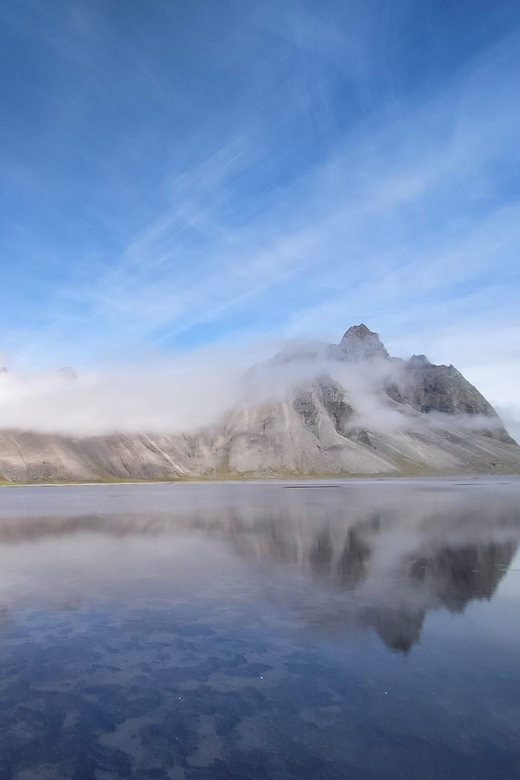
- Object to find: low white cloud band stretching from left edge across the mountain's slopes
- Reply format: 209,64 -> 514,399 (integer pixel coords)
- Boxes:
0,342 -> 515,437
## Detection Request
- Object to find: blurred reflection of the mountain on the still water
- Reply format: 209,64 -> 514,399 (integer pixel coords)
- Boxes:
0,486 -> 520,652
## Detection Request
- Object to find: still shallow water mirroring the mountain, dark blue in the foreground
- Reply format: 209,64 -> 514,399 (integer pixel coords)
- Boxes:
0,478 -> 520,780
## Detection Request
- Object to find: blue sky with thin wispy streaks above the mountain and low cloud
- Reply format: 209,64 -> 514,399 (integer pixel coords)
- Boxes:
0,0 -> 520,430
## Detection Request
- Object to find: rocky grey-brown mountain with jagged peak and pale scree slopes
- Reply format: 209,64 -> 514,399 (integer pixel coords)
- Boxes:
0,324 -> 520,482
